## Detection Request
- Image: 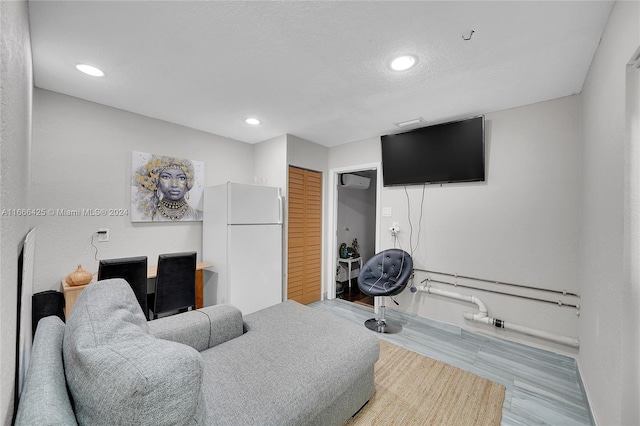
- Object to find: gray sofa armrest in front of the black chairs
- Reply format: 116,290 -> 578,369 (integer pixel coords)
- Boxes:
148,305 -> 243,351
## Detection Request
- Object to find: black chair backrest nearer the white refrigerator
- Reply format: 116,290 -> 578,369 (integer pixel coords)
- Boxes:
153,251 -> 196,318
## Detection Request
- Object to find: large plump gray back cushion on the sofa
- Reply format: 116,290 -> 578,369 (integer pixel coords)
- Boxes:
63,279 -> 206,425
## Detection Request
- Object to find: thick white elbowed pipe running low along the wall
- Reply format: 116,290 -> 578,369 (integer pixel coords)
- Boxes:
411,285 -> 580,348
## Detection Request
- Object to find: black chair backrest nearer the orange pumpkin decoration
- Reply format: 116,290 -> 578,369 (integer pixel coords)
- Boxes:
98,256 -> 149,318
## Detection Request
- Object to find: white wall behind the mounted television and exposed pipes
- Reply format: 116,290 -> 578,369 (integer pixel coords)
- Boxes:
329,96 -> 581,353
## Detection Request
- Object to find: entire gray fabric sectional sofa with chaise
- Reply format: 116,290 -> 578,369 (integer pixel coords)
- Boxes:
16,279 -> 379,426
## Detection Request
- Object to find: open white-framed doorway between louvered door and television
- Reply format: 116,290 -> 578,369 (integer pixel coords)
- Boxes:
327,164 -> 380,306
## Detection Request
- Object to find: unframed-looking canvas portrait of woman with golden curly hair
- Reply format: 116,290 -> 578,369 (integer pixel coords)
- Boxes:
131,151 -> 204,222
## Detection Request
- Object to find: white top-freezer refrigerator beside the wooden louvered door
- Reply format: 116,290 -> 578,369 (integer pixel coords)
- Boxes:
202,182 -> 283,314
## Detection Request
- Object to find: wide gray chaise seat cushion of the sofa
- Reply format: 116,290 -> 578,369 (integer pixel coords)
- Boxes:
202,300 -> 379,426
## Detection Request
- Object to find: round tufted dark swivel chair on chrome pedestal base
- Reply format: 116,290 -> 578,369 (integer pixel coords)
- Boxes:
358,248 -> 413,333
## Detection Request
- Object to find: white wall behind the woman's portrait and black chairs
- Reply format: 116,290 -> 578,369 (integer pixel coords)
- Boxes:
31,89 -> 254,291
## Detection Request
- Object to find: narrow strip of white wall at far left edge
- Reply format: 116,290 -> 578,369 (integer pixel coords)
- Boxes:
0,1 -> 33,425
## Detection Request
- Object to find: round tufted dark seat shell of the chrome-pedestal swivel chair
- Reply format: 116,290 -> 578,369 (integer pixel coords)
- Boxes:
358,248 -> 413,297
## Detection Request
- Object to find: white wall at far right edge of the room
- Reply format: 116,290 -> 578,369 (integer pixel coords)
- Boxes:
579,1 -> 640,424
